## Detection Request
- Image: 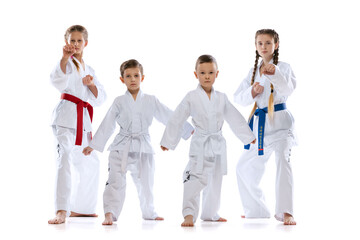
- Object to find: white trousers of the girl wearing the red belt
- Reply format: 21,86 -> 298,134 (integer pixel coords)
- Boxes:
53,126 -> 99,215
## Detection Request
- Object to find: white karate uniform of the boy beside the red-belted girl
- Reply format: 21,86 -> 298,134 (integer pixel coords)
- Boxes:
89,90 -> 193,221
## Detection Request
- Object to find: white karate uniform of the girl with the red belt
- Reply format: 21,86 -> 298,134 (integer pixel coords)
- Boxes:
50,58 -> 106,215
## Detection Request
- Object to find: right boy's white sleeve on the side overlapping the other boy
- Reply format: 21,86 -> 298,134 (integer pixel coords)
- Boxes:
160,96 -> 190,150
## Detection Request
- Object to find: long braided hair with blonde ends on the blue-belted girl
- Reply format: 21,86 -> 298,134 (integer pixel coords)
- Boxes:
249,29 -> 279,120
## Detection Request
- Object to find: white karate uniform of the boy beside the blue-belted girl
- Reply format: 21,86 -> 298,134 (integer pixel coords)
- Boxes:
161,85 -> 255,222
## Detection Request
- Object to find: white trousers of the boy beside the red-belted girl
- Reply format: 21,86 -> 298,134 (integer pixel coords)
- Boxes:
103,151 -> 158,221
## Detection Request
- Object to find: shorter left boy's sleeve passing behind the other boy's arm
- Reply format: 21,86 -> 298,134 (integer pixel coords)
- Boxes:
155,98 -> 194,140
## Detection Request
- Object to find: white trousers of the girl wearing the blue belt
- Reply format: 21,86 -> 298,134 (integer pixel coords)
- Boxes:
236,137 -> 293,221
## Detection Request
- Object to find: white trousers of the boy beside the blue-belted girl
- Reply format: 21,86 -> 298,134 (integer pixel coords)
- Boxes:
182,157 -> 223,222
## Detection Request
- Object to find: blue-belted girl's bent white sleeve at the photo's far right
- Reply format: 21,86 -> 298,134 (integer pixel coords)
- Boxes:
265,63 -> 296,96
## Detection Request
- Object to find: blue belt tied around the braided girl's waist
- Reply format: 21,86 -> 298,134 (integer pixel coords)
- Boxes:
244,103 -> 286,155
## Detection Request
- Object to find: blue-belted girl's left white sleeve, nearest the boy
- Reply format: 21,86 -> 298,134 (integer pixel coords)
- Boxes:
234,69 -> 256,106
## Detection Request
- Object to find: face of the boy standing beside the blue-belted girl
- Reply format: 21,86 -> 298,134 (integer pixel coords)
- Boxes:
194,63 -> 219,90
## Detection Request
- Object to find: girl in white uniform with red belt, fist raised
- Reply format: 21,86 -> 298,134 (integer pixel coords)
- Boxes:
48,25 -> 106,224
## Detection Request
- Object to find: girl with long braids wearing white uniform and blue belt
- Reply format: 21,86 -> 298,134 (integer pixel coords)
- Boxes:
235,29 -> 296,225
